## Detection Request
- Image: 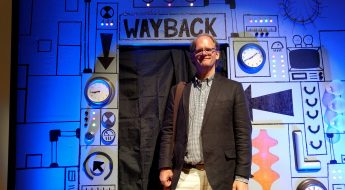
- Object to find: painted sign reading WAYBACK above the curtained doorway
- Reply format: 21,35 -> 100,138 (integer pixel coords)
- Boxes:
119,13 -> 227,41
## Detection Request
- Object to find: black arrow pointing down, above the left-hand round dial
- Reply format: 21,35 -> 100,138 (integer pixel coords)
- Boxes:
97,33 -> 114,70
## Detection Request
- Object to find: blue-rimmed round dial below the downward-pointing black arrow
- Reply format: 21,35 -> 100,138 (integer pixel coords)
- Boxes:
85,77 -> 114,106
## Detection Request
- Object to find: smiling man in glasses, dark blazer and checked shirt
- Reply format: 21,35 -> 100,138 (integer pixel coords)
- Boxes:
159,34 -> 252,190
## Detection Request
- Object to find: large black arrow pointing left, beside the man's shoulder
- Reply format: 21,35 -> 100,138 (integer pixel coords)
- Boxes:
244,85 -> 294,121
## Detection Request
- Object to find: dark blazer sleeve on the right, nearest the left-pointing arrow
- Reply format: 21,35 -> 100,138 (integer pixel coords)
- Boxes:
233,83 -> 252,179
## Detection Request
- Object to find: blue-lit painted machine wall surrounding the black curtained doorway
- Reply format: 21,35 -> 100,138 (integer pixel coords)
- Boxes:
16,0 -> 345,190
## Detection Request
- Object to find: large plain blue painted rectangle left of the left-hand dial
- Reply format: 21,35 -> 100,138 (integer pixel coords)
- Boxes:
26,76 -> 81,122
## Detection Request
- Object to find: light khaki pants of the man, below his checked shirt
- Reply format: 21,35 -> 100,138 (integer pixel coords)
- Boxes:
176,168 -> 212,190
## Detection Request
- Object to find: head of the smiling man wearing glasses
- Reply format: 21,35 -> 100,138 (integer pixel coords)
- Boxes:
190,33 -> 220,75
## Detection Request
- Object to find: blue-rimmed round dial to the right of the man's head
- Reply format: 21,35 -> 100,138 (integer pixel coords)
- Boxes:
237,43 -> 266,74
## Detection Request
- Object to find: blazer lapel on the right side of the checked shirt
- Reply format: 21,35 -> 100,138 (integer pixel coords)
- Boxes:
202,74 -> 222,126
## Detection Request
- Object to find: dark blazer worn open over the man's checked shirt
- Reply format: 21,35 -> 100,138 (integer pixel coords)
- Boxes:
159,74 -> 252,190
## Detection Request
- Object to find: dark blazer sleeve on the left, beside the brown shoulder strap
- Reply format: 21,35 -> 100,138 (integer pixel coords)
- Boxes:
158,86 -> 176,169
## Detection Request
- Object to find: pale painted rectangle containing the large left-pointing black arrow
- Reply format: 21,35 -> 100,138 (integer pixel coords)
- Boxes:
242,82 -> 304,124
